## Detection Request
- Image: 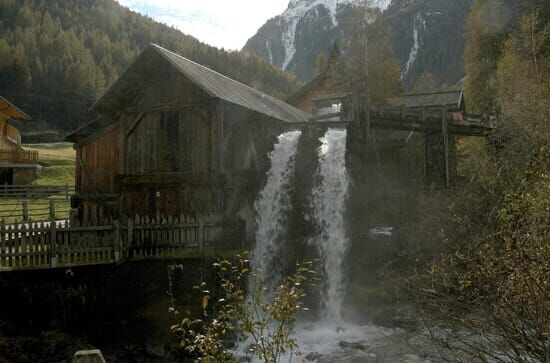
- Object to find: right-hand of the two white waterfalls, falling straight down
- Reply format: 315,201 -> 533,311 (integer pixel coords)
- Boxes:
311,129 -> 349,321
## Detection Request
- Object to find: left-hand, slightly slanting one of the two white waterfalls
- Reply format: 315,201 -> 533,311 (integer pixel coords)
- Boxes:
252,131 -> 301,286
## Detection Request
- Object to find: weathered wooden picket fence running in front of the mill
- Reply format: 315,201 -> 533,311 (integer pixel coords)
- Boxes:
0,215 -> 221,271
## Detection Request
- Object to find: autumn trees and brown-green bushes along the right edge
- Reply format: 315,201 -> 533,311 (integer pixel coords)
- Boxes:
410,0 -> 550,362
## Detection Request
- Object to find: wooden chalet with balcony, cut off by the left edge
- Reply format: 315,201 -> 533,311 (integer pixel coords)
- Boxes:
0,97 -> 39,185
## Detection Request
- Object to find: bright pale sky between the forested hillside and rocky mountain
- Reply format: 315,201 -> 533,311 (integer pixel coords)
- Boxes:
117,0 -> 289,49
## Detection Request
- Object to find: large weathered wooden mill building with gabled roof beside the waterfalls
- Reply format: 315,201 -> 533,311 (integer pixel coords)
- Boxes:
68,44 -> 308,236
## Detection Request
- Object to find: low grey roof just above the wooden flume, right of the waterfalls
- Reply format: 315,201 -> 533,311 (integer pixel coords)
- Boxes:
387,91 -> 465,110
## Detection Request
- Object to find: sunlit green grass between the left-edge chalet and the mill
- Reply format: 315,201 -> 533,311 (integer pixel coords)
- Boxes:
0,143 -> 75,223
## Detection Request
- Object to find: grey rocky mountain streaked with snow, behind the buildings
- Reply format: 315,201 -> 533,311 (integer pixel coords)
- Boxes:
244,0 -> 472,89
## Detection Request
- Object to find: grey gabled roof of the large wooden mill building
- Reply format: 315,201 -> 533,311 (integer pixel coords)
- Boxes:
91,44 -> 308,122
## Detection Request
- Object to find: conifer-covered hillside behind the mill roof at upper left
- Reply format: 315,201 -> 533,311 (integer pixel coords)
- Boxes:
0,0 -> 298,131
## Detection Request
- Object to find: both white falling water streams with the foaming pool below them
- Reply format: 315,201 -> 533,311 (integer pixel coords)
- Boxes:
235,129 -> 432,363
